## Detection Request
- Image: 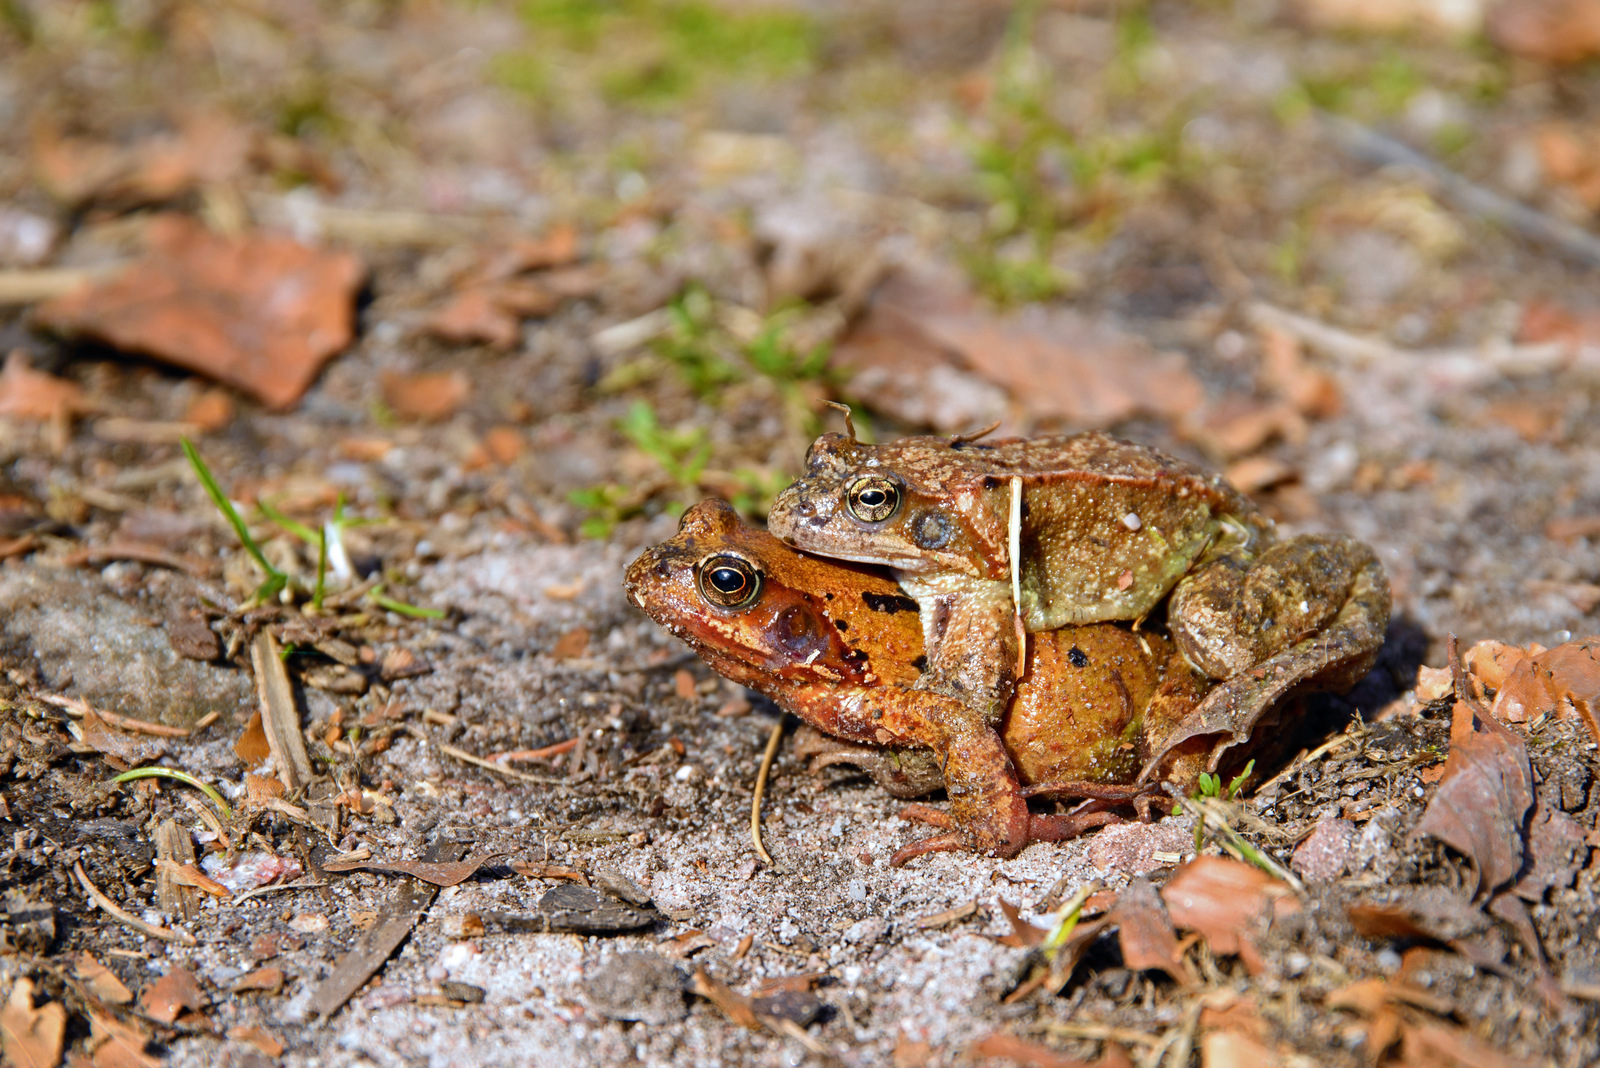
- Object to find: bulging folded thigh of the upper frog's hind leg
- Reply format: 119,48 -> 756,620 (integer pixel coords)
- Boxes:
1168,534 -> 1389,679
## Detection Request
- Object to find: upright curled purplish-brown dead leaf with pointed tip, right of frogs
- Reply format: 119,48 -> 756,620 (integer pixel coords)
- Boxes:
1416,697 -> 1533,899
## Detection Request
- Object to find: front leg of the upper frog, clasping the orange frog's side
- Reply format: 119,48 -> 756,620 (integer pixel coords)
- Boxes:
898,574 -> 1022,726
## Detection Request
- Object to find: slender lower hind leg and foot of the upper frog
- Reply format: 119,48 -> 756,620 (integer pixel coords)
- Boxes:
1138,549 -> 1389,782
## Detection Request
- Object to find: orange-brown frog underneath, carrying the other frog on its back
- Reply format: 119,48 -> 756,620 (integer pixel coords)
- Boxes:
626,500 -> 1208,863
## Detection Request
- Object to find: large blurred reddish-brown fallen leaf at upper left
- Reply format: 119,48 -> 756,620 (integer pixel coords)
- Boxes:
34,216 -> 365,409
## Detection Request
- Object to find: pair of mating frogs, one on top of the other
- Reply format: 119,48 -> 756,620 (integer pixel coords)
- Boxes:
627,430 -> 1389,863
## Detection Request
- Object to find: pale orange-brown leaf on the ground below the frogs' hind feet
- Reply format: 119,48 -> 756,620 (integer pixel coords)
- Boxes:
1162,857 -> 1299,975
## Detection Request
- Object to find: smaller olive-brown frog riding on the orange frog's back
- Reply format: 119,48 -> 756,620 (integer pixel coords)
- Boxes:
770,422 -> 1389,805
